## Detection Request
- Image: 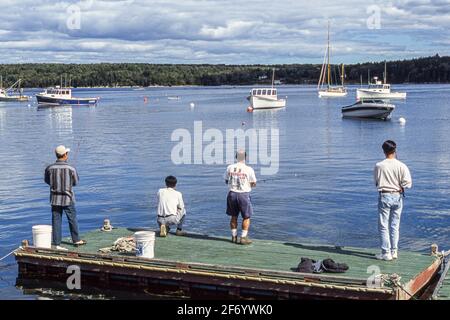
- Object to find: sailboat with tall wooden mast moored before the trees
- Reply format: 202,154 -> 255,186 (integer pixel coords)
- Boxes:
317,21 -> 347,98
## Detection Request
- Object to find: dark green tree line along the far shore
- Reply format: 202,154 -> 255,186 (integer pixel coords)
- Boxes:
0,55 -> 450,88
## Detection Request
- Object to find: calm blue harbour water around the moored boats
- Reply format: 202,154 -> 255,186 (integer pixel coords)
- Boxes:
0,85 -> 450,299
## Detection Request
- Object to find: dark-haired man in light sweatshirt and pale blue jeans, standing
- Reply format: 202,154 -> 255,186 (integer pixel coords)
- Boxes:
374,140 -> 412,261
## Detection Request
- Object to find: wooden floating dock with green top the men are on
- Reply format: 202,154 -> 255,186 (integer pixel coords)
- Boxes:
15,228 -> 443,300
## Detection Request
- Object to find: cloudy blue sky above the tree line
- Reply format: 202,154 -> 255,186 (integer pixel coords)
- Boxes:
0,0 -> 450,64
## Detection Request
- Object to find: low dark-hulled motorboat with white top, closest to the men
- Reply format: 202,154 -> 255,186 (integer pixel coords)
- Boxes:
342,99 -> 395,120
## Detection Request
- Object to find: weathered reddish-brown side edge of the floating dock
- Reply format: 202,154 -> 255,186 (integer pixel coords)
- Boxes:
14,247 -> 442,300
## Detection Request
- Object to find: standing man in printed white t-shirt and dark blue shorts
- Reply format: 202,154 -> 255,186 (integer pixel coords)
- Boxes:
224,150 -> 256,244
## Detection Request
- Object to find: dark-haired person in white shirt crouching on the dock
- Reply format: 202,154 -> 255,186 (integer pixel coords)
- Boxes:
157,176 -> 186,237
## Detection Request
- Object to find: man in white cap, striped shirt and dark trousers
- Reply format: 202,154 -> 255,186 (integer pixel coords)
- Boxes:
45,146 -> 86,250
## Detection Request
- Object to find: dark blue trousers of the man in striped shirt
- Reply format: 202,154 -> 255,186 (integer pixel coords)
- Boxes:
52,204 -> 80,246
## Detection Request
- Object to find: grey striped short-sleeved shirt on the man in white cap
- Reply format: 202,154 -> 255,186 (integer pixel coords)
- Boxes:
45,160 -> 79,206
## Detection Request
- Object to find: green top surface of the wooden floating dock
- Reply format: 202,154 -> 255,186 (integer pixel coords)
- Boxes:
66,228 -> 438,284
